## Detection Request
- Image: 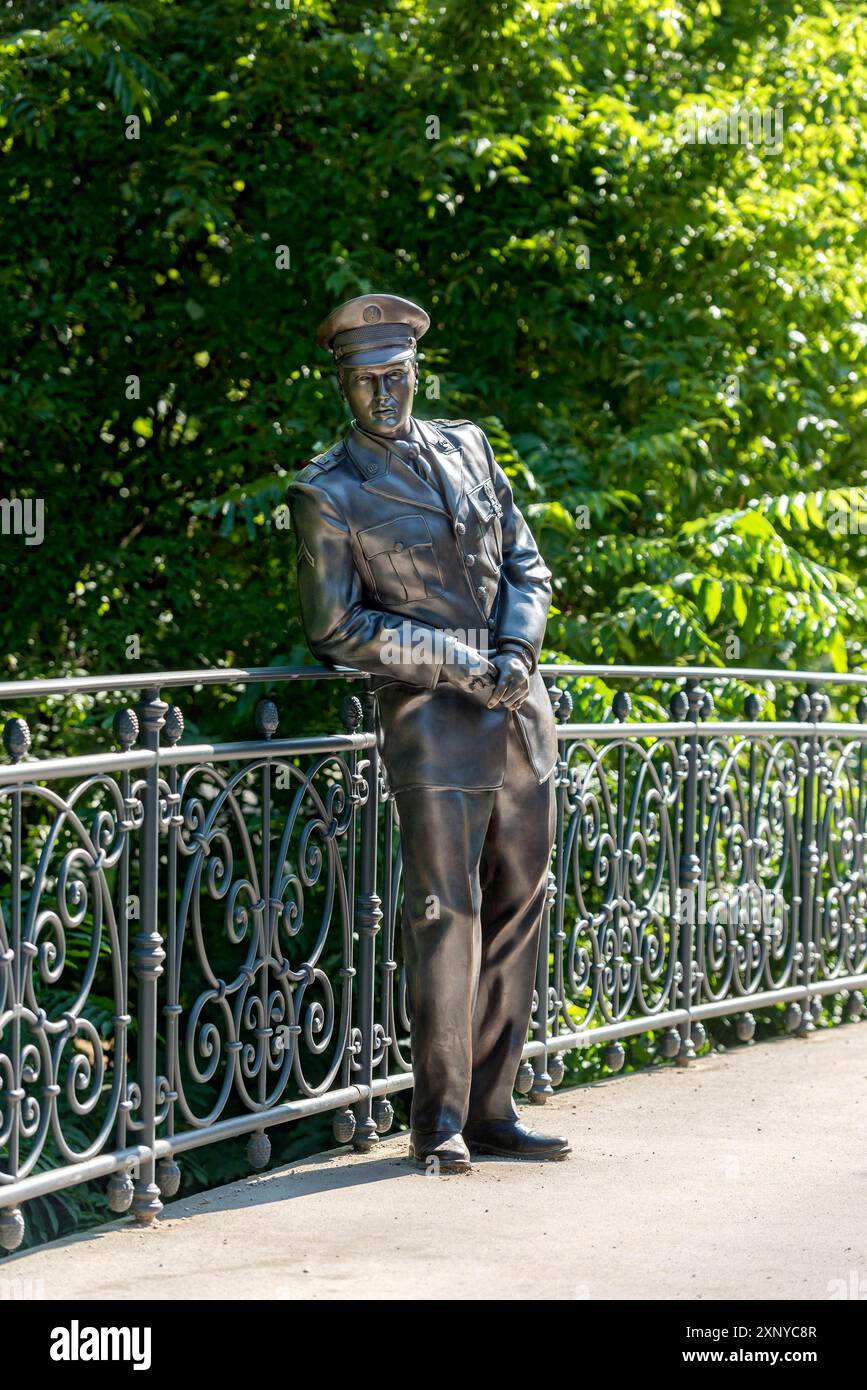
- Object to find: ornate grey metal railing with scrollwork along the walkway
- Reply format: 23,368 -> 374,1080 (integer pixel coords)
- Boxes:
0,666 -> 867,1250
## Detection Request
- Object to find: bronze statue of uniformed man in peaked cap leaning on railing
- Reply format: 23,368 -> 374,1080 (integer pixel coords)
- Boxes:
288,295 -> 570,1172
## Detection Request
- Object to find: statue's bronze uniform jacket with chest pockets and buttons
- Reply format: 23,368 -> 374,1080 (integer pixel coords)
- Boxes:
288,420 -> 557,791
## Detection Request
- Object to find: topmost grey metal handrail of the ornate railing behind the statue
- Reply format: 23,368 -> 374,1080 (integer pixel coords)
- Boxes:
0,662 -> 867,703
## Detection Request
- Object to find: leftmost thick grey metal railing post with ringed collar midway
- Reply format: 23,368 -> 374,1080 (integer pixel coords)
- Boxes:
132,687 -> 168,1226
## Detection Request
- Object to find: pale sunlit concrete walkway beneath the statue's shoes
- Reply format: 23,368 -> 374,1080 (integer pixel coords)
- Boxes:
6,1023 -> 867,1300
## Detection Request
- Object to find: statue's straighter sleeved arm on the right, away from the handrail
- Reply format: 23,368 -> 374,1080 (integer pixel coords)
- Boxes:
479,431 -> 552,670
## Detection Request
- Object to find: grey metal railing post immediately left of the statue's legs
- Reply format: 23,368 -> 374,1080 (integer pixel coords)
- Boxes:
353,691 -> 382,1154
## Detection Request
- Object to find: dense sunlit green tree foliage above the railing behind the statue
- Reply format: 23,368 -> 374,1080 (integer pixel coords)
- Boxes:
0,0 -> 867,717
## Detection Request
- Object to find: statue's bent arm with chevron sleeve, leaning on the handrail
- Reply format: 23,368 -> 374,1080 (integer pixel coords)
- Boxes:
286,482 -> 480,689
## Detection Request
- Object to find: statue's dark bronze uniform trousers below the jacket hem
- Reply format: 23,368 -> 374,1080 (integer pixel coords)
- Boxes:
395,712 -> 554,1134
